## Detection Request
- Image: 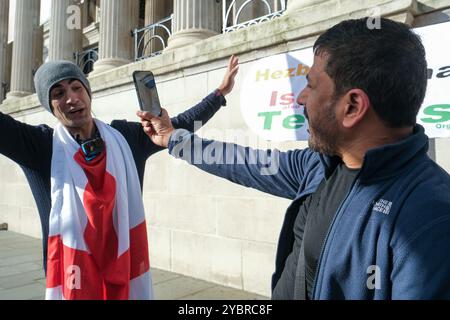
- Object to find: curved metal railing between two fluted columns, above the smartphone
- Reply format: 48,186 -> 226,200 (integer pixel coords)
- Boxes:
133,15 -> 173,61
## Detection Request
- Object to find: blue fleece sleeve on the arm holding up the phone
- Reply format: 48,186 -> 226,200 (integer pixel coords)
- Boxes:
169,129 -> 309,199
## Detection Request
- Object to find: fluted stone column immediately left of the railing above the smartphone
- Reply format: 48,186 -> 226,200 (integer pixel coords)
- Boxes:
91,0 -> 139,75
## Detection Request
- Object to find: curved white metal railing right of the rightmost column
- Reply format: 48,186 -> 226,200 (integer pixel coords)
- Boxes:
222,0 -> 286,33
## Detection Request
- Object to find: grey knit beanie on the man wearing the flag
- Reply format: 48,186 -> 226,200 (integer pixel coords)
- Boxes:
34,60 -> 92,113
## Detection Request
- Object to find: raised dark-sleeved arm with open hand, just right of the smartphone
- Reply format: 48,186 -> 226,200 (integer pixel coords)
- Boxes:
171,56 -> 239,131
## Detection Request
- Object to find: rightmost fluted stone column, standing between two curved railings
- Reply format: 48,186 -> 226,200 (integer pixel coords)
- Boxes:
167,0 -> 221,50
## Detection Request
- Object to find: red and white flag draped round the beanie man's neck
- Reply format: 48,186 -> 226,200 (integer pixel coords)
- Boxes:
46,120 -> 153,300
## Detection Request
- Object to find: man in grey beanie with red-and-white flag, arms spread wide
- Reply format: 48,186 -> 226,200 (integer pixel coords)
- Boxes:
0,59 -> 237,299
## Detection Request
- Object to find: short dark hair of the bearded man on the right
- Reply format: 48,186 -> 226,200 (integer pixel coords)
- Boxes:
314,18 -> 427,128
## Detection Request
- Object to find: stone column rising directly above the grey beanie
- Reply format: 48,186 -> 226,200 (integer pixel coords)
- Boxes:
48,0 -> 82,61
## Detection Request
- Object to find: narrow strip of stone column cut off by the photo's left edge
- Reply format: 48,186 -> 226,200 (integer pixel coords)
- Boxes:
0,0 -> 9,104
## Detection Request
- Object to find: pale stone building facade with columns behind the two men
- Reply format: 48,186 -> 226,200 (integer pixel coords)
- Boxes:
0,0 -> 450,296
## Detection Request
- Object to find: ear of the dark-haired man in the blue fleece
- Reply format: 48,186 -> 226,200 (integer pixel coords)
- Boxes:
342,89 -> 371,128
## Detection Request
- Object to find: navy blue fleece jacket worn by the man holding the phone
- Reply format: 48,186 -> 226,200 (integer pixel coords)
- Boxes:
169,125 -> 450,299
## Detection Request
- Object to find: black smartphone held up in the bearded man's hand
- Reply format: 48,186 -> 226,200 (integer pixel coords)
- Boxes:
133,71 -> 162,116
